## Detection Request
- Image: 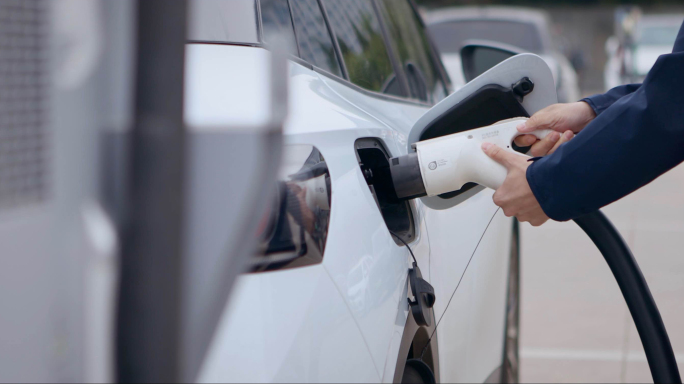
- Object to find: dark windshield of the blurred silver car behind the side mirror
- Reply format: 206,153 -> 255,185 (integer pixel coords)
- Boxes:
428,20 -> 544,53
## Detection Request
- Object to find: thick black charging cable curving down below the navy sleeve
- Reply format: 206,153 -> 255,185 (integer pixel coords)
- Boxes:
575,211 -> 682,383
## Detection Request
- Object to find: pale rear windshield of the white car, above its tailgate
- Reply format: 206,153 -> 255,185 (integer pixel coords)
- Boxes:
188,0 -> 258,43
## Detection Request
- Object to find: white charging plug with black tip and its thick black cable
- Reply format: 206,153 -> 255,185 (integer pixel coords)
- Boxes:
390,118 -> 681,383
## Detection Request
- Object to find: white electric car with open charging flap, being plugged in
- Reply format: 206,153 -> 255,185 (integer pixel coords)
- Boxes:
185,0 -> 556,382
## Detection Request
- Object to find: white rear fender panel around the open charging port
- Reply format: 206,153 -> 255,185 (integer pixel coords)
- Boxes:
285,73 -> 429,378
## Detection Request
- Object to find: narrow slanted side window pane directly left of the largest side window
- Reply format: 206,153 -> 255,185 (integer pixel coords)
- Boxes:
290,0 -> 342,76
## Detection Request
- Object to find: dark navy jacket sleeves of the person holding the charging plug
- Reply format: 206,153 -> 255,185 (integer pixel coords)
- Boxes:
527,24 -> 684,220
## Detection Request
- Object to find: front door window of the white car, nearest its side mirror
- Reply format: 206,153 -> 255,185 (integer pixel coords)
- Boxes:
381,0 -> 447,103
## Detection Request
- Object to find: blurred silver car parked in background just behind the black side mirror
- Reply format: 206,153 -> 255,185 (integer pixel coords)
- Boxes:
425,7 -> 580,102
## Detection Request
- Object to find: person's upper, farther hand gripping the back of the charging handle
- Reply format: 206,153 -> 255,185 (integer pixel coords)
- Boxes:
515,101 -> 596,156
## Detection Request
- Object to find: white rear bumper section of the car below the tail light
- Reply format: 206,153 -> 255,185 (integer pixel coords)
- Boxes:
198,265 -> 380,382
